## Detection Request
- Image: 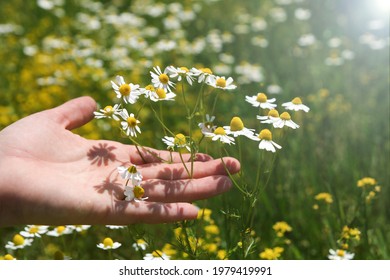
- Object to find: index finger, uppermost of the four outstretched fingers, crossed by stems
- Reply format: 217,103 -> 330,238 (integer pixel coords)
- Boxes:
130,146 -> 213,165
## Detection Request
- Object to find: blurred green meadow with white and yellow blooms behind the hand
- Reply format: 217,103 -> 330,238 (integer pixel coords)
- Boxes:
0,0 -> 390,259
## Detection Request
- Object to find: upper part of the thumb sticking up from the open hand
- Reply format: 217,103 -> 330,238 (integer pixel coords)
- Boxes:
47,96 -> 96,130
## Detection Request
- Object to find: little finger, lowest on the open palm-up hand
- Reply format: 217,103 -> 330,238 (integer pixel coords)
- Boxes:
103,201 -> 199,225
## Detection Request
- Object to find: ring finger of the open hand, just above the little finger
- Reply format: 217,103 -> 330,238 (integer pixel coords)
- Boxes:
142,176 -> 232,202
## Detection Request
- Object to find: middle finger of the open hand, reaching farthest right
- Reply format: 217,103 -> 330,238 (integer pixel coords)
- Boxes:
138,157 -> 240,180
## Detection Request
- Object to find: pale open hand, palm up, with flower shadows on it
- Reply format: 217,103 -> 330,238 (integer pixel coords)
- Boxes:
0,97 -> 240,226
